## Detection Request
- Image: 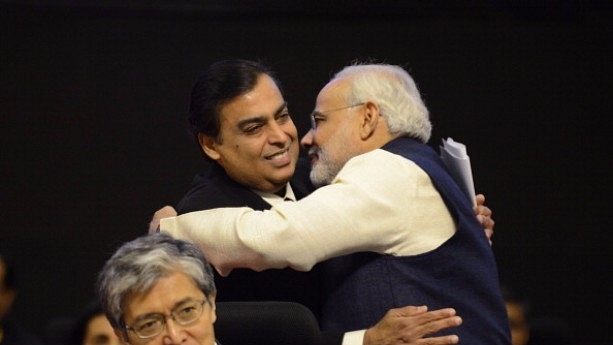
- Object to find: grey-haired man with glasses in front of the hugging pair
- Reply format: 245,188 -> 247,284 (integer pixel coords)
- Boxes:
98,234 -> 217,345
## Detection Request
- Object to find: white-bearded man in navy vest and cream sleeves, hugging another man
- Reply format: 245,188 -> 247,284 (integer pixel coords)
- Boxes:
155,65 -> 510,344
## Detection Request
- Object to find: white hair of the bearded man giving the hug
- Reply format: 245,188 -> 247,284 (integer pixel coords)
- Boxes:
332,63 -> 432,143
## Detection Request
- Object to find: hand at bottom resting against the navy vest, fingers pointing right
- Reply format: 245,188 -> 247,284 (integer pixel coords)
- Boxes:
363,306 -> 462,345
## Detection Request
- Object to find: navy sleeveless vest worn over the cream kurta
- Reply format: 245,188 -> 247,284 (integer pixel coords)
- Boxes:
321,138 -> 510,345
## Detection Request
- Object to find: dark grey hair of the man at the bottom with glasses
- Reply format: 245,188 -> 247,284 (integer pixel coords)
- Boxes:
98,233 -> 216,329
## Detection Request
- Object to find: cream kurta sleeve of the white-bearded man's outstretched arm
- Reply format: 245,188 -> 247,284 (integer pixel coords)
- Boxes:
160,150 -> 454,275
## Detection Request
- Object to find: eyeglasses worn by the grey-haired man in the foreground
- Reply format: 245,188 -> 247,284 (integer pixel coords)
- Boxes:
125,299 -> 208,339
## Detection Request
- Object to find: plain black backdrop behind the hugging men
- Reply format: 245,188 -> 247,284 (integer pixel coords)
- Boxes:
0,1 -> 613,344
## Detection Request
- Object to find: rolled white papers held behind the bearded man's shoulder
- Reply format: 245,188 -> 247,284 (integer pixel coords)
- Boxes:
441,138 -> 477,207
